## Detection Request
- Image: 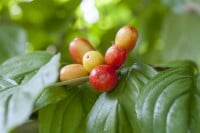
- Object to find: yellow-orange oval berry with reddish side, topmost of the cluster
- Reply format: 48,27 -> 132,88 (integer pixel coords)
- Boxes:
115,25 -> 138,53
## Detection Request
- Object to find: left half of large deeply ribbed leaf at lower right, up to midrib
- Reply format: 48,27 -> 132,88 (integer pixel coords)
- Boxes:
136,67 -> 196,133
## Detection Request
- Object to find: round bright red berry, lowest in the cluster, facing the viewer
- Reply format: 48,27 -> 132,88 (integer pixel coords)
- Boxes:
89,65 -> 118,92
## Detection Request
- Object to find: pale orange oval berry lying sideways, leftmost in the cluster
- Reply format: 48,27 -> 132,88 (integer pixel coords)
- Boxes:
60,64 -> 88,81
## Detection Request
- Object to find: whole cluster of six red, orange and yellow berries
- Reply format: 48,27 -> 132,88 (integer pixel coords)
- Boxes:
60,26 -> 138,91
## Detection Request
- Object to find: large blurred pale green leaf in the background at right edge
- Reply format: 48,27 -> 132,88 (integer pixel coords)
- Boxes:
161,14 -> 200,65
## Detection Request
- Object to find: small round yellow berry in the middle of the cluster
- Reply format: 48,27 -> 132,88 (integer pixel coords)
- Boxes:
83,51 -> 104,72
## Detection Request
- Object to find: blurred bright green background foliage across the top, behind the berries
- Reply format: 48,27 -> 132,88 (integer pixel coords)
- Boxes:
0,0 -> 200,66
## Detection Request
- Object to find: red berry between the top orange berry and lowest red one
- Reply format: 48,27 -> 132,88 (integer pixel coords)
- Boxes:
105,45 -> 126,69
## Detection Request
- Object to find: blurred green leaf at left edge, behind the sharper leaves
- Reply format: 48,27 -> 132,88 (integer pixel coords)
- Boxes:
0,24 -> 26,63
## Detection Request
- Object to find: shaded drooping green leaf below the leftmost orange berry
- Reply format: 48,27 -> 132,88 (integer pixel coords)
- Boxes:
39,84 -> 98,133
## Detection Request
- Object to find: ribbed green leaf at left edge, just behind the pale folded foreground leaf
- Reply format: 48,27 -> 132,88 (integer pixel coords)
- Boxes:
0,51 -> 52,79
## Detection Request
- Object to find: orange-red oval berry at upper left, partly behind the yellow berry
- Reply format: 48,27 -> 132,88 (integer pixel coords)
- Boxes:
69,37 -> 94,64
